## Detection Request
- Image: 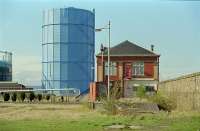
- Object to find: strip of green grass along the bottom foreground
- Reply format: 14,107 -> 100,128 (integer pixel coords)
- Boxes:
0,114 -> 200,131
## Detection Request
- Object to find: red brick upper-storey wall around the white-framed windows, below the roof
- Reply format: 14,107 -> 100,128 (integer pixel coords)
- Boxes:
97,56 -> 159,82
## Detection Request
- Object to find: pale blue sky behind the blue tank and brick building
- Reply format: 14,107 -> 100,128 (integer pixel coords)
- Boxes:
0,0 -> 200,84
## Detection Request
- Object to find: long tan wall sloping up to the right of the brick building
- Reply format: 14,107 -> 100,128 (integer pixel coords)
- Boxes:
159,72 -> 200,111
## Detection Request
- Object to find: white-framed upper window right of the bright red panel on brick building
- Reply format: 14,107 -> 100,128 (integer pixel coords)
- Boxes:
132,61 -> 144,76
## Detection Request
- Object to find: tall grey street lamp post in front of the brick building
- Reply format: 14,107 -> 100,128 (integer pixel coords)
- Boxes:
95,21 -> 111,100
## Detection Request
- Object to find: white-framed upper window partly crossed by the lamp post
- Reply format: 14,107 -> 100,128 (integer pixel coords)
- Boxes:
104,62 -> 117,76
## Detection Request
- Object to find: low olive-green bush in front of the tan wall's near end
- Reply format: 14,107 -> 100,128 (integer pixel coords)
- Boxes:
151,93 -> 176,112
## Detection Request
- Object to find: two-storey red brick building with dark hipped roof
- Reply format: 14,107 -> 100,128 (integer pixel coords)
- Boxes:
96,40 -> 160,97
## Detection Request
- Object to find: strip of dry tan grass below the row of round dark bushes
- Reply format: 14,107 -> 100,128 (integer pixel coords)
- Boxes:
0,103 -> 97,120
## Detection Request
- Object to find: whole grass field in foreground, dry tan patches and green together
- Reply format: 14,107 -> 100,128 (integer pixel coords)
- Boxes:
0,103 -> 200,131
